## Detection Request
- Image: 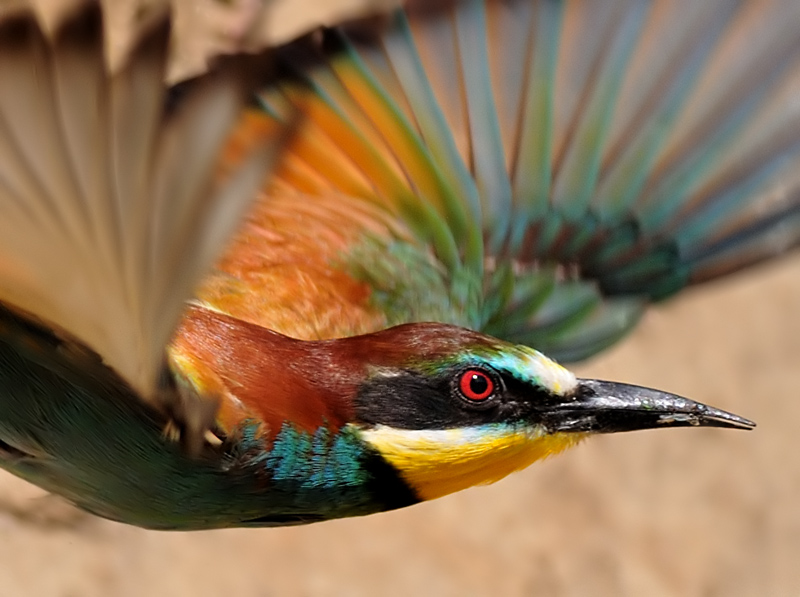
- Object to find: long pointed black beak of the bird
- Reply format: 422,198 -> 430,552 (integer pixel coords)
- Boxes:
542,379 -> 756,433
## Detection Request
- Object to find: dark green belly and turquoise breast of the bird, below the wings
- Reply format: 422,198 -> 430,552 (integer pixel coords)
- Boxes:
0,304 -> 416,529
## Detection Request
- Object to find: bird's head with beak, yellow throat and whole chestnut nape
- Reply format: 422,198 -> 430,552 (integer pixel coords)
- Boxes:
174,308 -> 753,507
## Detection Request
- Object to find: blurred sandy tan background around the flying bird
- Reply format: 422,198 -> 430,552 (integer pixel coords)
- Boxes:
0,0 -> 800,597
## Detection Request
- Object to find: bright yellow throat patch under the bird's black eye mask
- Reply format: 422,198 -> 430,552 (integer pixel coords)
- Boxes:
361,425 -> 586,500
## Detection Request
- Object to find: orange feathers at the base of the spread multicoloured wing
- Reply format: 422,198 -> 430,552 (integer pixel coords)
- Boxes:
197,112 -> 388,340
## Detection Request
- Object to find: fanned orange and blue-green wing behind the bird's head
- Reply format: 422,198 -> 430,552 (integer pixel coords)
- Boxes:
200,0 -> 800,361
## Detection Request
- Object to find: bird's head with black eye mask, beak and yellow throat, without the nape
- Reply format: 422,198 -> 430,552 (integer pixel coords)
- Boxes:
326,324 -> 753,499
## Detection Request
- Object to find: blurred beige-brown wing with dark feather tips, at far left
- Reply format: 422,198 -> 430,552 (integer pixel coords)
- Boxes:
0,3 -> 280,399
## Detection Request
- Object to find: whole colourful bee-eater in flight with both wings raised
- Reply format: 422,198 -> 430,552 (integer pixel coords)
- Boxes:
0,0 -> 800,529
